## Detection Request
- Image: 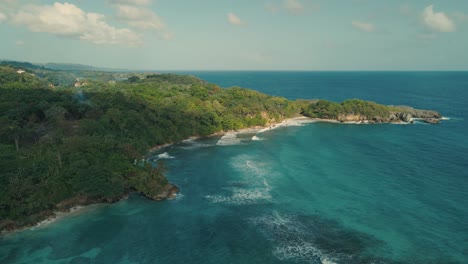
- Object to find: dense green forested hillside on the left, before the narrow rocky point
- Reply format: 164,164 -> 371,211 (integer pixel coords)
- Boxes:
0,66 -> 300,230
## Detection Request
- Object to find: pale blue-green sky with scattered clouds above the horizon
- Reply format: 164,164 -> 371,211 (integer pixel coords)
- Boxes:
0,0 -> 468,71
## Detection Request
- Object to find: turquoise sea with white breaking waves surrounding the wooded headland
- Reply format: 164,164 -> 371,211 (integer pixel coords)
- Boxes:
0,72 -> 468,263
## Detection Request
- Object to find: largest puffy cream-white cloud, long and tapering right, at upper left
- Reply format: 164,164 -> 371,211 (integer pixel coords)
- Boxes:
12,3 -> 141,46
